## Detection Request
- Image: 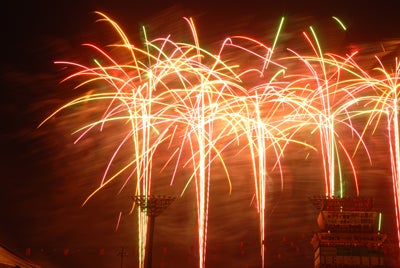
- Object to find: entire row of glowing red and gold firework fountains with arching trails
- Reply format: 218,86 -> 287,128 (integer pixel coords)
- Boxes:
35,13 -> 400,268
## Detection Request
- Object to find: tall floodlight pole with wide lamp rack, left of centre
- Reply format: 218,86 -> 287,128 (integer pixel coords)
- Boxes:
133,195 -> 176,268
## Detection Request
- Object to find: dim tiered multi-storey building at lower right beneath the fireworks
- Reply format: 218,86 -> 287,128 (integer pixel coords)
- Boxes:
311,197 -> 387,268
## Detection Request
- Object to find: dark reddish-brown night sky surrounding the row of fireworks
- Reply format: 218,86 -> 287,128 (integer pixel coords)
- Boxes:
0,0 -> 400,268
